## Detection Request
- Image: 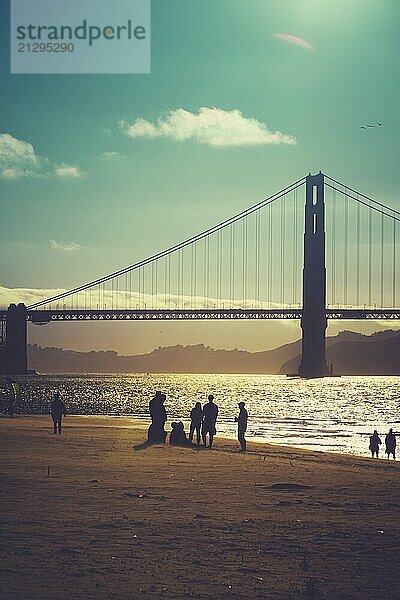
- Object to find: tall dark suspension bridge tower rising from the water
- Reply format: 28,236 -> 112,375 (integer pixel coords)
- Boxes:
299,171 -> 328,377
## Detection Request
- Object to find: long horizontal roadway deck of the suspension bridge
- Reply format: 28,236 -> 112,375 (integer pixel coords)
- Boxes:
0,308 -> 400,324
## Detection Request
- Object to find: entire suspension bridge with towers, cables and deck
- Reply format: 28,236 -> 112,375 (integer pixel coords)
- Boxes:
0,172 -> 400,377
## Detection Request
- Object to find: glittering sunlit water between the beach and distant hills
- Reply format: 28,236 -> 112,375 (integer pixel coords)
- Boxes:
3,374 -> 400,455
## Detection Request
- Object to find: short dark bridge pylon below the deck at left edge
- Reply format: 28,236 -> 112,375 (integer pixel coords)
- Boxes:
3,304 -> 28,375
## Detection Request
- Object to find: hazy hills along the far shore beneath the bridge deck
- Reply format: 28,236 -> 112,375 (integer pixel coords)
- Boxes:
28,330 -> 400,375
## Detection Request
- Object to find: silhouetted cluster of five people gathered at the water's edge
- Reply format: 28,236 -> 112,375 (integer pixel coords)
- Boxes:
147,391 -> 248,452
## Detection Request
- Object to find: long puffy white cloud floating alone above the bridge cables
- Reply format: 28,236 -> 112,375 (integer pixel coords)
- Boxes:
119,106 -> 296,147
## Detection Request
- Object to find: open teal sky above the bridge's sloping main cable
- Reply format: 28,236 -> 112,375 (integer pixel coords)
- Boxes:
0,0 -> 400,351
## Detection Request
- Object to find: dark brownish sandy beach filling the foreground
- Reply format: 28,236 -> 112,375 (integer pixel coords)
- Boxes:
0,416 -> 400,600
